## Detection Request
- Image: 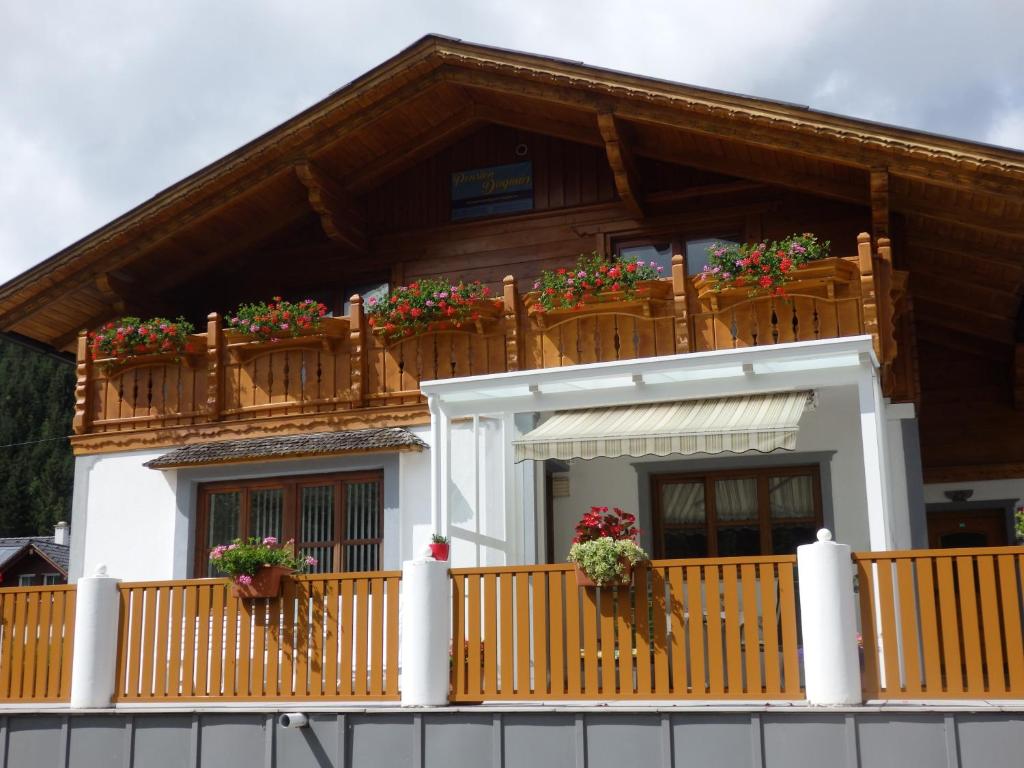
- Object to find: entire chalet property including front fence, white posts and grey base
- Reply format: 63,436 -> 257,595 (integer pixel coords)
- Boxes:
0,36 -> 1024,766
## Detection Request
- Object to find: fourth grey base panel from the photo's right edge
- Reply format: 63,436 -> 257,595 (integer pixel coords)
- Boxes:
672,714 -> 754,768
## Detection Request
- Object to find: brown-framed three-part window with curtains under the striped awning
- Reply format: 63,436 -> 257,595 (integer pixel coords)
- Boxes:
651,467 -> 821,558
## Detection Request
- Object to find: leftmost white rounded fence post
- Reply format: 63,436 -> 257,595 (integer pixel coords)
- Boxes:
71,565 -> 121,710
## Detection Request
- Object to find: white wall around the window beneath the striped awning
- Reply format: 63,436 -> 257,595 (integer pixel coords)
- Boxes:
554,387 -> 868,560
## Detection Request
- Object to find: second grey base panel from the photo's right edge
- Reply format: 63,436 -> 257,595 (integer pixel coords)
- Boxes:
857,713 -> 946,768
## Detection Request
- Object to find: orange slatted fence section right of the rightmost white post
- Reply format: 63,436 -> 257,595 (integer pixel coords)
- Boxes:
854,547 -> 1024,698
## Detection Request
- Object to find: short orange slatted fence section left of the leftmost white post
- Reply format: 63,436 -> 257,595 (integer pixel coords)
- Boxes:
0,585 -> 75,701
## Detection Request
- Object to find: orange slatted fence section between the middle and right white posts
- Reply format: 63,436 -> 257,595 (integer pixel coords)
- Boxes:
452,556 -> 803,702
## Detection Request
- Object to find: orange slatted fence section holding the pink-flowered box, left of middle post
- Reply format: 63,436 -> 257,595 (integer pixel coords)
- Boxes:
115,571 -> 401,701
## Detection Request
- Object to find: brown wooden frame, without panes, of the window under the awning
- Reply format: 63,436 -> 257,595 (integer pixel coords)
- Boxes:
650,464 -> 823,559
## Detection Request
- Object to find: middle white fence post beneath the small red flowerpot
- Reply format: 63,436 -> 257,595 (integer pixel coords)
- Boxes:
400,560 -> 452,707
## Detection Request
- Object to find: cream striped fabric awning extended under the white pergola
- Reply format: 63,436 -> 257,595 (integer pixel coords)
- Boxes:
513,391 -> 811,462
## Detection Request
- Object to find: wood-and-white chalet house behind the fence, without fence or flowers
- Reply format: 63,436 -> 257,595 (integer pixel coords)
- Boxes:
0,37 -> 1024,584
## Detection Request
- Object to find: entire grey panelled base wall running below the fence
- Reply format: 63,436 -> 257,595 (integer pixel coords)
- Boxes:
0,706 -> 1024,768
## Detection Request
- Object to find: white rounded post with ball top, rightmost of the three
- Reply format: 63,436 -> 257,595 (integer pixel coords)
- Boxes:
797,528 -> 862,707
